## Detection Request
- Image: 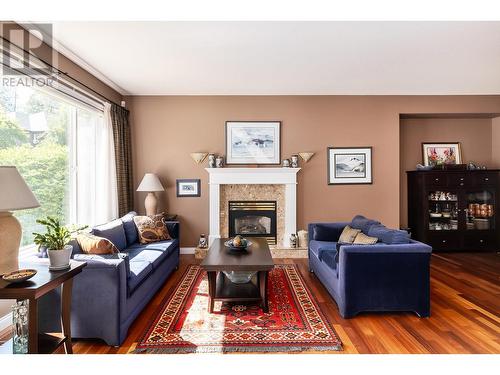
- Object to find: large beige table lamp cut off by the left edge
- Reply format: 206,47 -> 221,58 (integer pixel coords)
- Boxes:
0,166 -> 40,275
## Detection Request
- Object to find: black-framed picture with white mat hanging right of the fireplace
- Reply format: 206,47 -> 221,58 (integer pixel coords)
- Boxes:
327,147 -> 373,185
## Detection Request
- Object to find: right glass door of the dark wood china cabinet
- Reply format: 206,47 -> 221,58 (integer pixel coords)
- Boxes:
465,189 -> 496,230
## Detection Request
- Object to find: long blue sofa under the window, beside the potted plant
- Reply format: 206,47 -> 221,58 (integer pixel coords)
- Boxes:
40,212 -> 179,346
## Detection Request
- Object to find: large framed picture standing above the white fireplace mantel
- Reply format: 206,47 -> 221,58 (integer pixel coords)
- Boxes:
226,121 -> 281,164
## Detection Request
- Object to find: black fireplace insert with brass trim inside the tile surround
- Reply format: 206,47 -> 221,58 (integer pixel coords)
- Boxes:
228,201 -> 277,245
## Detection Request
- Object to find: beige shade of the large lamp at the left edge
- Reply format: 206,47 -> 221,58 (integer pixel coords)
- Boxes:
0,166 -> 40,211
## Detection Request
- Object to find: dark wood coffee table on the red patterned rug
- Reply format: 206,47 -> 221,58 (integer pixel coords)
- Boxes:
201,237 -> 274,312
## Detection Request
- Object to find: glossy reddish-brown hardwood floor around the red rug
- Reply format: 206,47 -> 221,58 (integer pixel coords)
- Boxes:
3,253 -> 500,354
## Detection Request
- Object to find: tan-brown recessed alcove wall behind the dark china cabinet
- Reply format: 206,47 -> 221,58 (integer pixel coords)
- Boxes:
400,118 -> 492,226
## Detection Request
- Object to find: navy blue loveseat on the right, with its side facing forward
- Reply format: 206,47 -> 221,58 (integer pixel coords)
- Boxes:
308,215 -> 432,318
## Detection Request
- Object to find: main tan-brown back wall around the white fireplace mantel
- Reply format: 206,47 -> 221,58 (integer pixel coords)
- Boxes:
126,96 -> 500,246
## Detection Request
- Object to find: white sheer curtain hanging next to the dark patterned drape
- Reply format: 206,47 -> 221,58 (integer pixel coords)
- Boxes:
72,103 -> 118,226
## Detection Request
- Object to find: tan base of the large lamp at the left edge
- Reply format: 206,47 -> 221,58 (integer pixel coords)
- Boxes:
0,212 -> 22,275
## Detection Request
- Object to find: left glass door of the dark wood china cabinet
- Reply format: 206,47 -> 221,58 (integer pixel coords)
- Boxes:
428,190 -> 458,231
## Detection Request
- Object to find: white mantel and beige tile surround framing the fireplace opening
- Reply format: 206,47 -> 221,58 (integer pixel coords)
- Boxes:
206,167 -> 300,248
